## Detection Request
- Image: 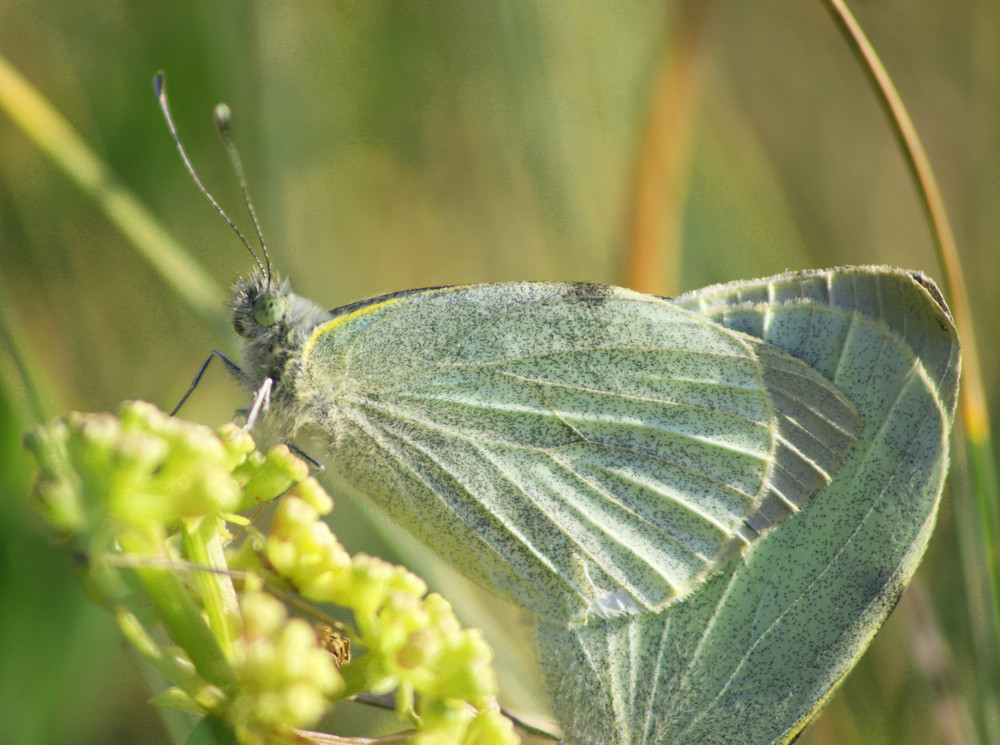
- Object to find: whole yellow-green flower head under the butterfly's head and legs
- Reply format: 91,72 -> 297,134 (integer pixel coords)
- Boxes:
25,402 -> 516,745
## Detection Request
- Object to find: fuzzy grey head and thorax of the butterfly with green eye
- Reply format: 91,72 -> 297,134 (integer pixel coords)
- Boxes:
232,272 -> 330,439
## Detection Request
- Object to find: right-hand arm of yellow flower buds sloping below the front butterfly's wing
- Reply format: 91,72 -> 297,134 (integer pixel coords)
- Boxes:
266,488 -> 516,745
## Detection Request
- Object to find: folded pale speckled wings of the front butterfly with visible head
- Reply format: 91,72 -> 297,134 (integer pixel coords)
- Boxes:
303,283 -> 862,623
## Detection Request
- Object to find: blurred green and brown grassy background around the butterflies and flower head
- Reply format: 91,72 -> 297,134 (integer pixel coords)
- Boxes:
0,0 -> 1000,745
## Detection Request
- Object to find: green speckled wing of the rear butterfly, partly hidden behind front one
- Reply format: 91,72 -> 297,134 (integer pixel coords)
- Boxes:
537,267 -> 959,745
